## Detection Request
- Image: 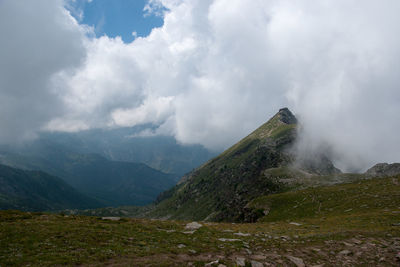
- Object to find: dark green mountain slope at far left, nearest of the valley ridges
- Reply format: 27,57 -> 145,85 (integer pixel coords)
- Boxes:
0,165 -> 100,211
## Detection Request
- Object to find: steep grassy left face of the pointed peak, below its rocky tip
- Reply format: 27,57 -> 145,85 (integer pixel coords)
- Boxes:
150,113 -> 296,221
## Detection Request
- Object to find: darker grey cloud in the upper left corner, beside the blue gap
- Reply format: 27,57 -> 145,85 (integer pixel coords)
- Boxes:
0,0 -> 86,142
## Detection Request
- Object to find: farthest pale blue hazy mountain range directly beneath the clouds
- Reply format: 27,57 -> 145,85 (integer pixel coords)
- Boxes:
9,125 -> 217,177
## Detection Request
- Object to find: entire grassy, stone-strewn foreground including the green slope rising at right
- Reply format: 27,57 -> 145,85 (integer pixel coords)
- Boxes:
0,176 -> 400,266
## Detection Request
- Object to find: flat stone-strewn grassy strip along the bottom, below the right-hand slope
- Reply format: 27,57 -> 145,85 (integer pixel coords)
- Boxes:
0,210 -> 400,267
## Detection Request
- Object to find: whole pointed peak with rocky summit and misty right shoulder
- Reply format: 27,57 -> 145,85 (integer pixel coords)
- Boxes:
148,108 -> 342,221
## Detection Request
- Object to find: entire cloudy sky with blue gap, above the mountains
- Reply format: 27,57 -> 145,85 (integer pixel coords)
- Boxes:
0,0 -> 400,170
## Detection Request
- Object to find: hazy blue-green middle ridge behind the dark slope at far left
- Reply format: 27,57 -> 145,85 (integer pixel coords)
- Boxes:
0,152 -> 176,206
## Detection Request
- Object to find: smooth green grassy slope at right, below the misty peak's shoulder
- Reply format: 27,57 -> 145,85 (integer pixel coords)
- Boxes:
247,175 -> 400,222
